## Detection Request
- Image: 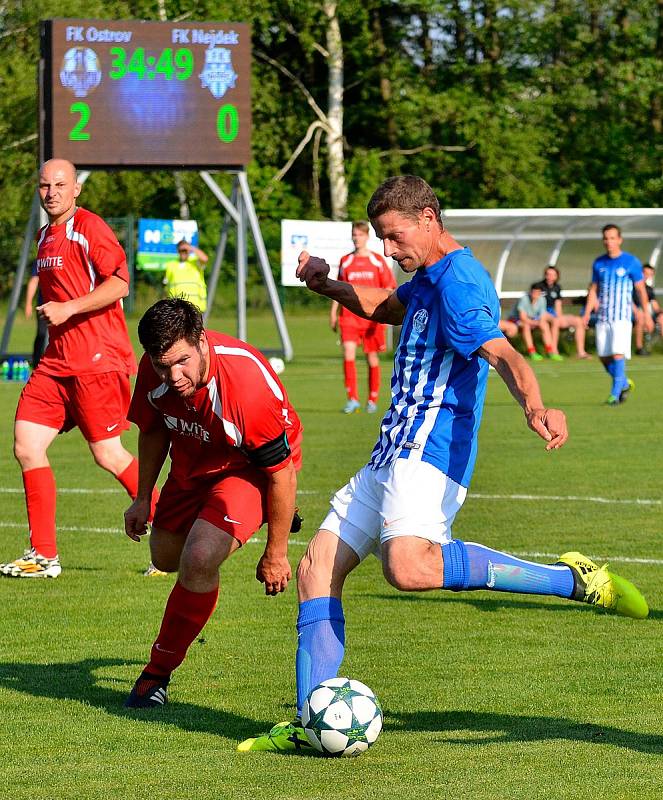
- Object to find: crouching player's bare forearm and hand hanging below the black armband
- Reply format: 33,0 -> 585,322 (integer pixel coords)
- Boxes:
256,462 -> 297,595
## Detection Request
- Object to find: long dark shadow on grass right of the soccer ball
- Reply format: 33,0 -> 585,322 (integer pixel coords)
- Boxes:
385,711 -> 663,754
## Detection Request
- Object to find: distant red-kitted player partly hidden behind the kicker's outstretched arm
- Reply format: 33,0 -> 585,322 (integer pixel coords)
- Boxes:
329,221 -> 396,414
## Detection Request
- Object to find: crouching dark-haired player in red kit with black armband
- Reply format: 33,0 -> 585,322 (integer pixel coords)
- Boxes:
125,298 -> 302,708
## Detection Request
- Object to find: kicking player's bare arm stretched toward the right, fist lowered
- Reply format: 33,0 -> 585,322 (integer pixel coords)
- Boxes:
478,339 -> 569,450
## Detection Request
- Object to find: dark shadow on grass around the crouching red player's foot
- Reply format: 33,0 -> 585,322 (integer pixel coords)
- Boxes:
0,658 -> 274,741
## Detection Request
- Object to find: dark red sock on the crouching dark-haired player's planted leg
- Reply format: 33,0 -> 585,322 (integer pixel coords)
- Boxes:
145,581 -> 219,675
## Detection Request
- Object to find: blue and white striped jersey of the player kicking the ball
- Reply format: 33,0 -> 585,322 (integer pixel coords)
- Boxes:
369,247 -> 503,487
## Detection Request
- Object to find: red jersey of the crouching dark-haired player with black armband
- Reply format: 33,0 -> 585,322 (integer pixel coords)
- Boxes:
127,331 -> 302,483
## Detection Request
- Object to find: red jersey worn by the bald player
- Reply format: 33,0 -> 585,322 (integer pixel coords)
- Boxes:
36,208 -> 136,377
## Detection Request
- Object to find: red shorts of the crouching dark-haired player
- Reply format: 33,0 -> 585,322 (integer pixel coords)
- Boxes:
153,470 -> 267,544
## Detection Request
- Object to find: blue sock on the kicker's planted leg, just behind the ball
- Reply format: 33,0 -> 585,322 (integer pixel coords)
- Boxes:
295,597 -> 345,717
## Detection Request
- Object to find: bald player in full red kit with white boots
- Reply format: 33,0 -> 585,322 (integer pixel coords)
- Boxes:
0,159 -> 154,578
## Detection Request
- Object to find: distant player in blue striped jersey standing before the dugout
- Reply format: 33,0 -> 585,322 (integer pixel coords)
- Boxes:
582,224 -> 648,406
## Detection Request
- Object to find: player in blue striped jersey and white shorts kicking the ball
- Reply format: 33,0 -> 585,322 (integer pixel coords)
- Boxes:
238,175 -> 648,752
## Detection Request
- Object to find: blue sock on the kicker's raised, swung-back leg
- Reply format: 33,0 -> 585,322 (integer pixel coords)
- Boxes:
442,539 -> 574,597
